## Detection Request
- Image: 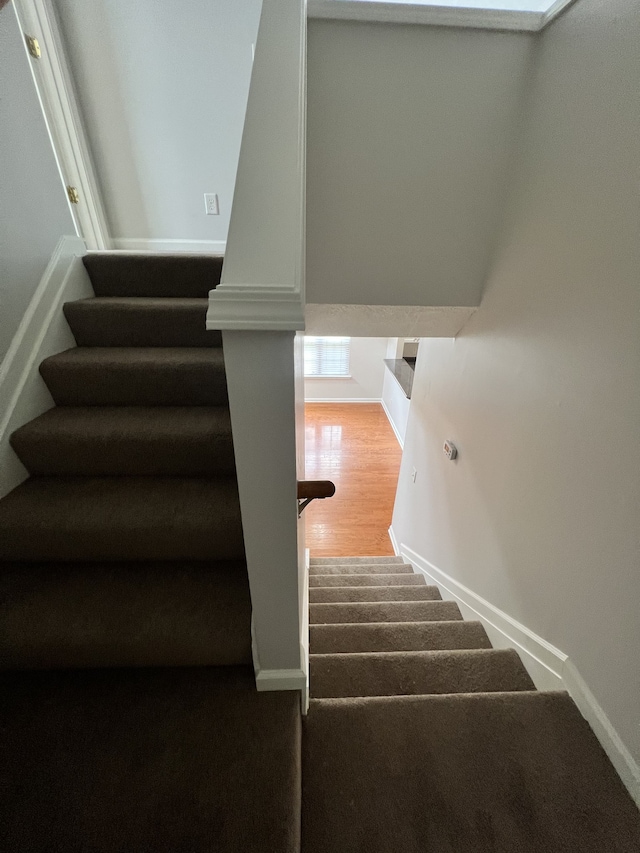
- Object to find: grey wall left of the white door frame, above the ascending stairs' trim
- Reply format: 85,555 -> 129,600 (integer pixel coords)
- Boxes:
0,4 -> 75,361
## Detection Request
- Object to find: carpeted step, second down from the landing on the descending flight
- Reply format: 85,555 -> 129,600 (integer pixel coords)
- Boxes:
309,621 -> 491,654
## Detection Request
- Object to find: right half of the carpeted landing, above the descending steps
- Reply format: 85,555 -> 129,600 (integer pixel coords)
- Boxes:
302,692 -> 640,853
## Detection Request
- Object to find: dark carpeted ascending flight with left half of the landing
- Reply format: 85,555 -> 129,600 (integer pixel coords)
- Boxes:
0,253 -> 300,853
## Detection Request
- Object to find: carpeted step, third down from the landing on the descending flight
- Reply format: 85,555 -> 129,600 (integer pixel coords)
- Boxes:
309,601 -> 462,625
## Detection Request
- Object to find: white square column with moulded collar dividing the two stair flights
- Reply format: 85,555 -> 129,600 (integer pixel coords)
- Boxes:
207,0 -> 308,691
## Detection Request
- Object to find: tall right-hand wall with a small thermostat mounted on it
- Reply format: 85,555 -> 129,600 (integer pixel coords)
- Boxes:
393,0 -> 640,760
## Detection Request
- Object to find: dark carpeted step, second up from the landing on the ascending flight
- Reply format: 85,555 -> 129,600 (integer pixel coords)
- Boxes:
0,477 -> 244,561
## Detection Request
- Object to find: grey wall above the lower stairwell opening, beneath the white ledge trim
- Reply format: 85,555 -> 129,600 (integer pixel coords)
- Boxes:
307,20 -> 534,310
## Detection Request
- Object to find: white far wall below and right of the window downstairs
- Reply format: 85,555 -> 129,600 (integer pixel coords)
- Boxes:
304,338 -> 388,402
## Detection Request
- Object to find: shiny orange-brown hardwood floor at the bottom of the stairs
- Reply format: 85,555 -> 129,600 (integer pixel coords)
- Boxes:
304,403 -> 402,557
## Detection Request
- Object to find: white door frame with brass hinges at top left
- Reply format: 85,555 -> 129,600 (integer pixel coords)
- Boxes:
14,0 -> 111,249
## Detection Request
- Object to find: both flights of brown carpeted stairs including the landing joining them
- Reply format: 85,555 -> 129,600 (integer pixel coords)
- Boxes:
0,253 -> 640,853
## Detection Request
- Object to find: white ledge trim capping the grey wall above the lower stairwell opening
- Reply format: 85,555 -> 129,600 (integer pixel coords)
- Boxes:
309,0 -> 574,33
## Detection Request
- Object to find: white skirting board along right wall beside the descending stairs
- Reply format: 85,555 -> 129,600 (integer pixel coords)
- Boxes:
396,527 -> 640,806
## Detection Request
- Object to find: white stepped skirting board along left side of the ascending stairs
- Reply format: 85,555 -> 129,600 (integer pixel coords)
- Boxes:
0,237 -> 93,497
